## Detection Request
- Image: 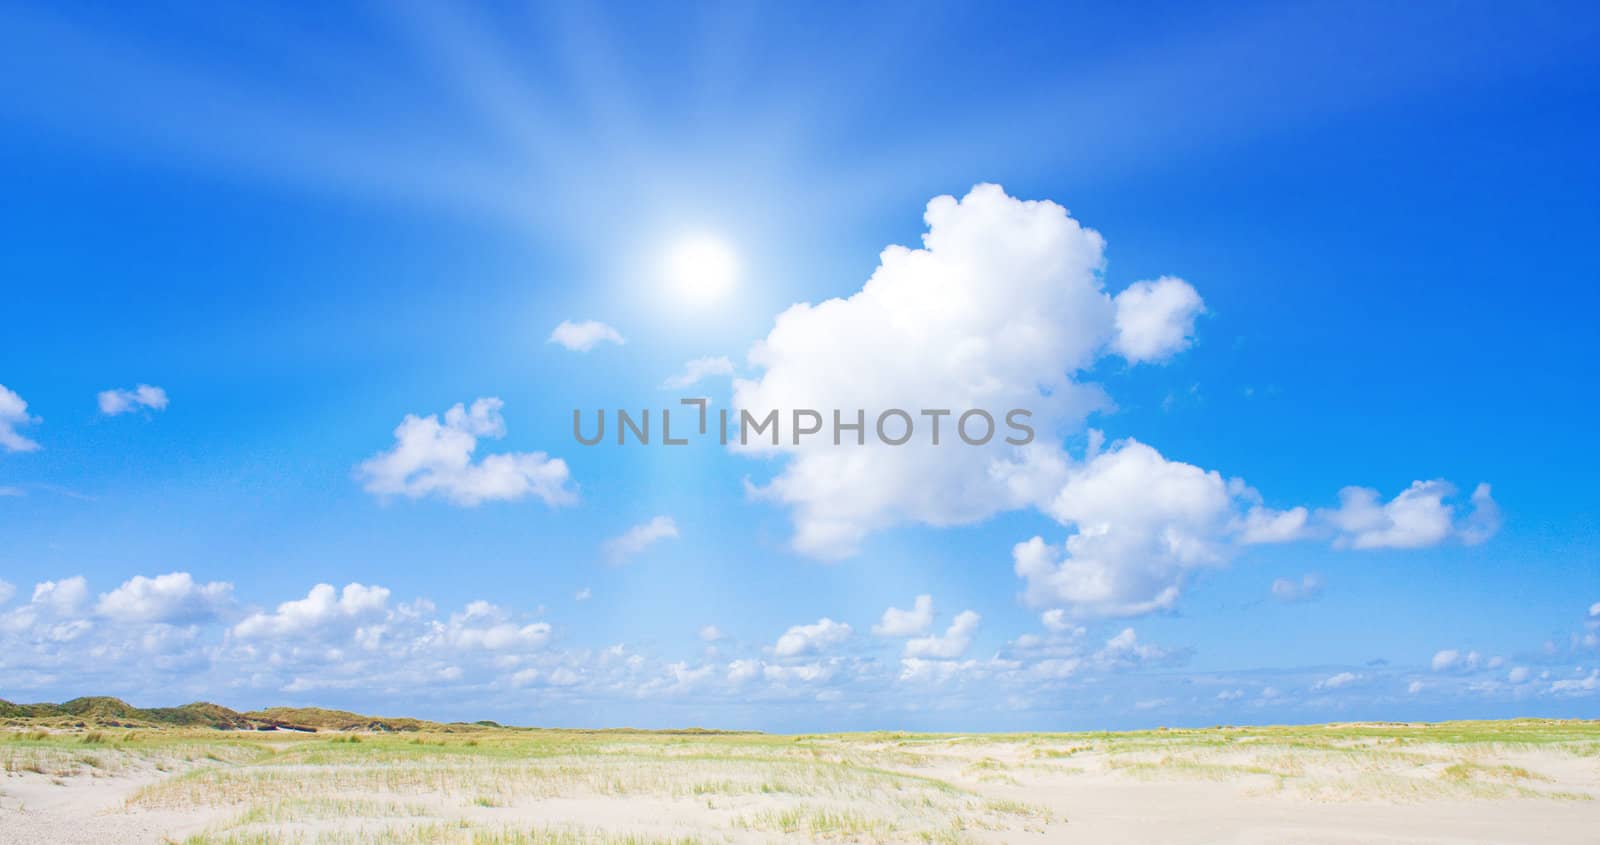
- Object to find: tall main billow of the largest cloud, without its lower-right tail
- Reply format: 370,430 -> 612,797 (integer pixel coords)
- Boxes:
733,184 -> 1115,557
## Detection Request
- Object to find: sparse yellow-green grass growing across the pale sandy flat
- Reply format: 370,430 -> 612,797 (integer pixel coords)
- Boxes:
0,720 -> 1600,845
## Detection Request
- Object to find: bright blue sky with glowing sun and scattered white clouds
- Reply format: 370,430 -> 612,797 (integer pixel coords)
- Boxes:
0,3 -> 1600,730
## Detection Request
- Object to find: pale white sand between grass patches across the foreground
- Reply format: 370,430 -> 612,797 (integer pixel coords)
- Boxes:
0,738 -> 1600,845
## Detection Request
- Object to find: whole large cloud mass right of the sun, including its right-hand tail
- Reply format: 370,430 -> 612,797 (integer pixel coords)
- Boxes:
733,184 -> 1499,616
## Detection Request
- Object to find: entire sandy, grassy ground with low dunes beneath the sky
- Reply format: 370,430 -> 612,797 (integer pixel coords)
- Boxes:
0,698 -> 1600,843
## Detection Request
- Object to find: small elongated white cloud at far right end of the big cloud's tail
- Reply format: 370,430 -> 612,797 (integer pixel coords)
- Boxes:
1318,480 -> 1499,549
